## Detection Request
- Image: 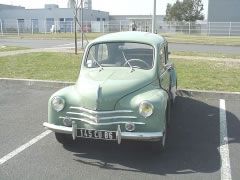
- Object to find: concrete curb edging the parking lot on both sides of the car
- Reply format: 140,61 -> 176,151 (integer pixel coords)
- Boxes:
0,78 -> 240,99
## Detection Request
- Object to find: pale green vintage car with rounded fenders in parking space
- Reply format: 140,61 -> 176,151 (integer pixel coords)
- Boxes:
43,32 -> 177,149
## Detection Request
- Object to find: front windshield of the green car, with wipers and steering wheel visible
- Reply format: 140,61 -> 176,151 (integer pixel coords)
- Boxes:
85,42 -> 154,70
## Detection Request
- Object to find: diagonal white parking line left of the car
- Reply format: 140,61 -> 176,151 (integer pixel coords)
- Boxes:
0,130 -> 52,165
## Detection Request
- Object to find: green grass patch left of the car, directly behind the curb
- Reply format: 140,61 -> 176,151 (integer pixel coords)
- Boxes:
0,52 -> 82,81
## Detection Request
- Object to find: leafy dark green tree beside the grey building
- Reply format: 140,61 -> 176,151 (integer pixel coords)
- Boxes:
164,0 -> 204,22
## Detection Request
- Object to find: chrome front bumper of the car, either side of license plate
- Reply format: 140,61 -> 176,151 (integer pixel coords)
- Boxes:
43,121 -> 163,144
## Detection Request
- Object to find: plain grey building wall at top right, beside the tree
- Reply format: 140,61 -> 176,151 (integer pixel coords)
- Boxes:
208,0 -> 240,22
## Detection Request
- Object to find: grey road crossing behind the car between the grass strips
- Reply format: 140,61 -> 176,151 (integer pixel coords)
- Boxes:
0,39 -> 240,54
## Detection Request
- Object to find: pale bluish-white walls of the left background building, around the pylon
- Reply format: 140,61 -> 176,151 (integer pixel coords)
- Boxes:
0,5 -> 109,33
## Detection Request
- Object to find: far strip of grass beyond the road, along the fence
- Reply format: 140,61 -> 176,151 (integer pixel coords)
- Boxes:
0,33 -> 240,46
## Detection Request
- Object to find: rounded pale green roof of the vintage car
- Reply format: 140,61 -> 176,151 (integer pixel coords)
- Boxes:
91,31 -> 165,47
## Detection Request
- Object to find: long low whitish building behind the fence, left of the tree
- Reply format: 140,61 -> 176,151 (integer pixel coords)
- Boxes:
0,0 -> 167,34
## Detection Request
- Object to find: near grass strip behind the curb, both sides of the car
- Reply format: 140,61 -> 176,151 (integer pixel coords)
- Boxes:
0,52 -> 240,92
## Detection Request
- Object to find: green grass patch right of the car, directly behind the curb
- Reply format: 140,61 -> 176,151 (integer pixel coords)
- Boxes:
173,58 -> 240,92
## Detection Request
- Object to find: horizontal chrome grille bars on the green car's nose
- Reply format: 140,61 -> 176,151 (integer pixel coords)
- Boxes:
60,107 -> 145,125
